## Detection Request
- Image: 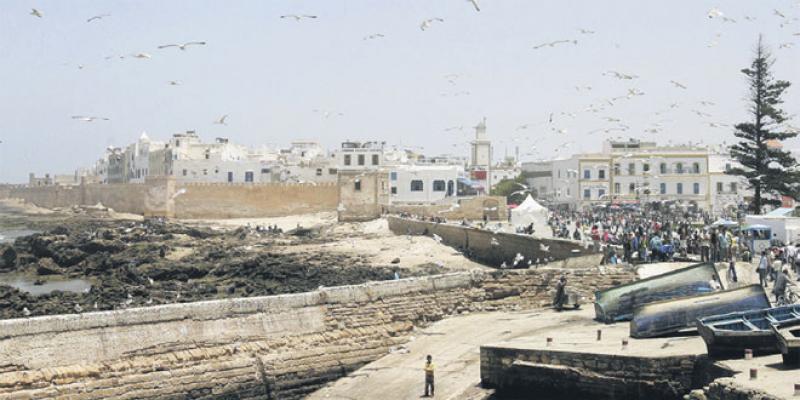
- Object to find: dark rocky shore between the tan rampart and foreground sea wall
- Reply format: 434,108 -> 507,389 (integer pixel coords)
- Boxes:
0,217 -> 442,319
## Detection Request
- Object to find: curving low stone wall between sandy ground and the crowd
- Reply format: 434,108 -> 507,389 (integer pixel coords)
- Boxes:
387,217 -> 602,268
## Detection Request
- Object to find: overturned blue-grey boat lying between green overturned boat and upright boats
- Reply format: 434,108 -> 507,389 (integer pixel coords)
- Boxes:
630,285 -> 770,338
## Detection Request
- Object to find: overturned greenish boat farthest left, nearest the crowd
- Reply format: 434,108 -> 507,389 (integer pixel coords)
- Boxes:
594,263 -> 721,323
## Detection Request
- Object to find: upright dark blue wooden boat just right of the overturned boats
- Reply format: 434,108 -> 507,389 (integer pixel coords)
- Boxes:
697,305 -> 800,357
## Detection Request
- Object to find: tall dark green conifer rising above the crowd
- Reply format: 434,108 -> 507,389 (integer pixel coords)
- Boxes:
728,36 -> 800,214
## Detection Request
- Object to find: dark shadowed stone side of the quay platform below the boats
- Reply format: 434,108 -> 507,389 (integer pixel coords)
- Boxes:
481,346 -> 720,400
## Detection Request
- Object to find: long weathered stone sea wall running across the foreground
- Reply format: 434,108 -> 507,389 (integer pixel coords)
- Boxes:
0,268 -> 635,399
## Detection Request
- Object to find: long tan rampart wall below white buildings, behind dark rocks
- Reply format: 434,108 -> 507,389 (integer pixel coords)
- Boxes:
0,178 -> 338,219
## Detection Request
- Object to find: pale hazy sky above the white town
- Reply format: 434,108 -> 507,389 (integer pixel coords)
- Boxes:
0,0 -> 800,183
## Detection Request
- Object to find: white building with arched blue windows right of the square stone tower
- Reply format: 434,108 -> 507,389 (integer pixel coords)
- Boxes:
387,165 -> 464,204
